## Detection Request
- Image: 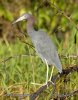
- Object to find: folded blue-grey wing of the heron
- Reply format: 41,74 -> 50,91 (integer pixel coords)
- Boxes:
35,31 -> 62,72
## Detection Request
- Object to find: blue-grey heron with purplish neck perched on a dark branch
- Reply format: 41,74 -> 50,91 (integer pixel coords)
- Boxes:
13,13 -> 62,84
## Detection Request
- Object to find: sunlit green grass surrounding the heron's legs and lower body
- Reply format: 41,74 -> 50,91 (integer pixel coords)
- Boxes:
0,39 -> 78,100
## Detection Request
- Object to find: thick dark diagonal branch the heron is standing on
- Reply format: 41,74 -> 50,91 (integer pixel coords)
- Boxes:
30,65 -> 78,100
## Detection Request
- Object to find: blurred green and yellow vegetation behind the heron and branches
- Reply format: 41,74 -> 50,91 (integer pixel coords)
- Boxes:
0,0 -> 78,100
